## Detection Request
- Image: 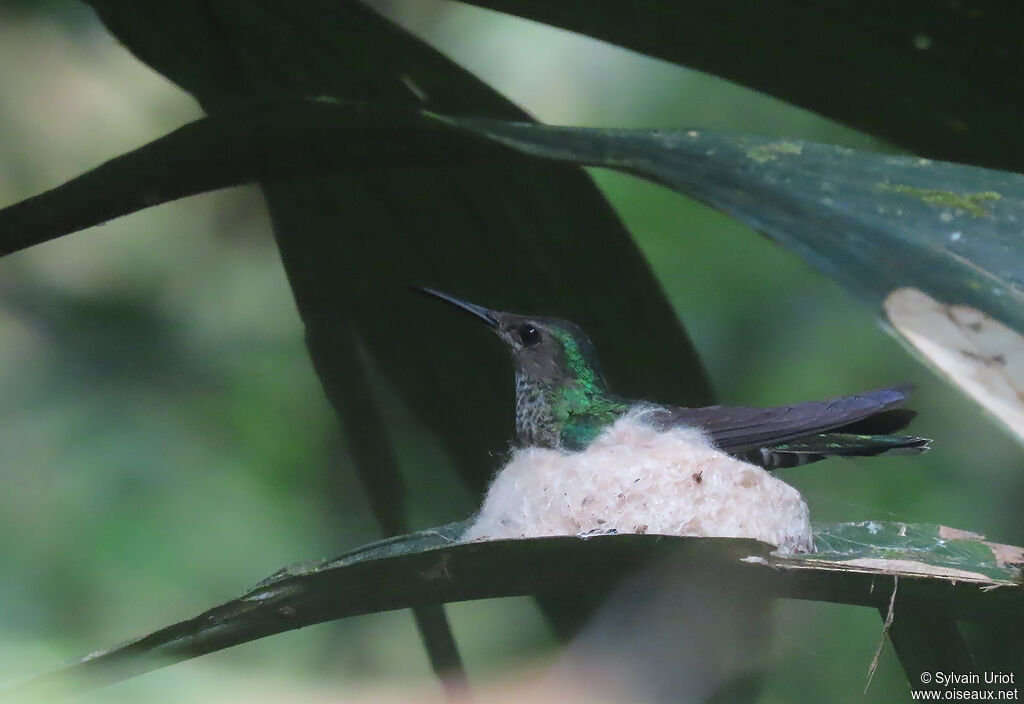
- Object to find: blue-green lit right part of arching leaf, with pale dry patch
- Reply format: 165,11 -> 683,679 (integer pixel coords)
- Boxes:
441,118 -> 1024,439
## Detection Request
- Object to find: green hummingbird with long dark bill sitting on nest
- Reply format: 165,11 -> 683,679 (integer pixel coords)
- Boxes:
419,288 -> 931,470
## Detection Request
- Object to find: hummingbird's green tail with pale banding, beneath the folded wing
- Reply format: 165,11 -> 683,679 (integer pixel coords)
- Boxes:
742,433 -> 931,470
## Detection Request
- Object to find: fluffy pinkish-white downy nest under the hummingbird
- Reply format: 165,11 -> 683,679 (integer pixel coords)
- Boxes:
463,408 -> 814,553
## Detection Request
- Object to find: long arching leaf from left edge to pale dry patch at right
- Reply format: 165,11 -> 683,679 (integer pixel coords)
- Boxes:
6,101 -> 1024,436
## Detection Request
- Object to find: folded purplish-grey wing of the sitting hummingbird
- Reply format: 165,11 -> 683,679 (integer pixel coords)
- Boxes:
647,386 -> 914,454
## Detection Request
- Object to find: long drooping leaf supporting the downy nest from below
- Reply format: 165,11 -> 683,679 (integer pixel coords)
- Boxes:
8,523 -> 1024,695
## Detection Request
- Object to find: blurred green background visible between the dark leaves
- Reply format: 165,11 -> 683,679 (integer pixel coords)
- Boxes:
0,0 -> 1024,702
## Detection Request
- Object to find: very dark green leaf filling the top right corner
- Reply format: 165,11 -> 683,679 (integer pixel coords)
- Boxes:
462,0 -> 1024,171
